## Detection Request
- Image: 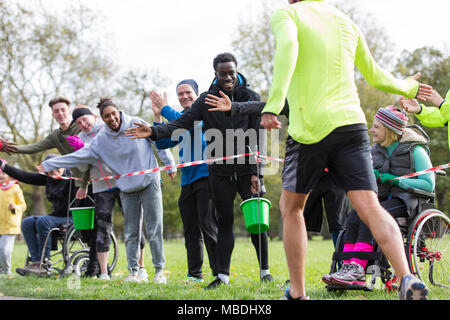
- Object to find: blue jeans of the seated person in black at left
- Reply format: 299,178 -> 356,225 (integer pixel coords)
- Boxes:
22,216 -> 72,262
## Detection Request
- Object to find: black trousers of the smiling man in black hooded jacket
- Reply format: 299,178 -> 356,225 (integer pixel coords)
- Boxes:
209,174 -> 269,275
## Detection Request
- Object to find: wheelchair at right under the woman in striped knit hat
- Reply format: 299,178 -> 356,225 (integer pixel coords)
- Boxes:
325,172 -> 450,292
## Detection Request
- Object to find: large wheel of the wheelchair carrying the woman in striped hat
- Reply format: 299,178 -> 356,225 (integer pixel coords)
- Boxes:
408,209 -> 450,288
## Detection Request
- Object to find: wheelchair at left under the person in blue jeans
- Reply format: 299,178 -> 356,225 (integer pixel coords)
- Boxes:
25,222 -> 118,277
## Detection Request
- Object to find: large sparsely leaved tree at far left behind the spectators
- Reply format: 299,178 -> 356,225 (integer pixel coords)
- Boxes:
0,1 -> 113,214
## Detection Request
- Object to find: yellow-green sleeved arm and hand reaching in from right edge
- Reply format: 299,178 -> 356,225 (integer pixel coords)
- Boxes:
400,90 -> 450,150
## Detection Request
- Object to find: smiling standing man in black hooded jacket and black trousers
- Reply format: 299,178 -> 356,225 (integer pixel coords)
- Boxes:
125,53 -> 272,289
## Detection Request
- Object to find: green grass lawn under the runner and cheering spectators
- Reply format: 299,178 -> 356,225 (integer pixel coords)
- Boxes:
0,239 -> 449,300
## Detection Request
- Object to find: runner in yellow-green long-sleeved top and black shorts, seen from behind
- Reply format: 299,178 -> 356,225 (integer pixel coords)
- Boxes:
261,0 -> 431,300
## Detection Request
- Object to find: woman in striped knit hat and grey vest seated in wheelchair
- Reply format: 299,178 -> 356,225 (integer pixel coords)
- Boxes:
322,106 -> 435,287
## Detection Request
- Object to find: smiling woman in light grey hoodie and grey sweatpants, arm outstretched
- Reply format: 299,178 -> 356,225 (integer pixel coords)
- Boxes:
42,98 -> 176,283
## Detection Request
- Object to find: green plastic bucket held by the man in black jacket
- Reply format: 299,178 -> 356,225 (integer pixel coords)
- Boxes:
241,198 -> 272,234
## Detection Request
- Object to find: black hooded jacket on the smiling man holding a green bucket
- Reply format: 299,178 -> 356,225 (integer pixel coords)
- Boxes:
150,74 -> 261,176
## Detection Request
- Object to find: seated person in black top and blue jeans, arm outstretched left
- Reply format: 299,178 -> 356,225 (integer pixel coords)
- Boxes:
0,154 -> 76,276
